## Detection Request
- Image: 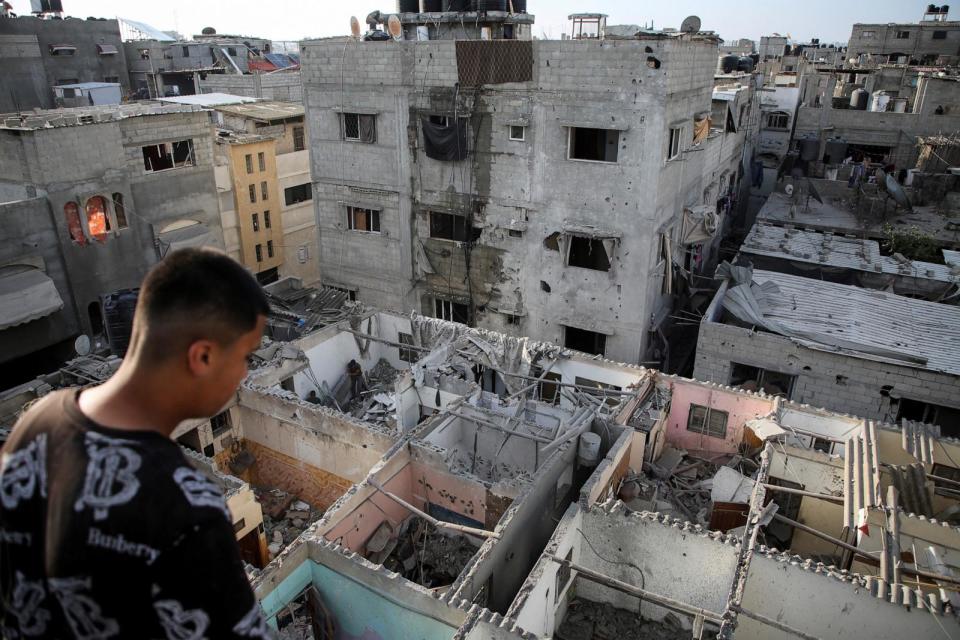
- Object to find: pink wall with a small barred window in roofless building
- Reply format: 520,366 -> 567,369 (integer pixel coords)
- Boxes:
667,380 -> 773,453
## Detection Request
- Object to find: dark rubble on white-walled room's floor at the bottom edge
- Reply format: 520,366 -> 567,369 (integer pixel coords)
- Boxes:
554,598 -> 690,640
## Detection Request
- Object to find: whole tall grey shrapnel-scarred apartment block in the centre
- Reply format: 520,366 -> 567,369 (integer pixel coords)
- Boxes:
302,10 -> 753,365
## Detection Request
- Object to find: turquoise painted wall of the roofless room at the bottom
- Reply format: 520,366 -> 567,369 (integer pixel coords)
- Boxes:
261,560 -> 456,640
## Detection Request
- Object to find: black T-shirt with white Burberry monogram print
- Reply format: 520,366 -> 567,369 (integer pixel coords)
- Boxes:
0,389 -> 271,640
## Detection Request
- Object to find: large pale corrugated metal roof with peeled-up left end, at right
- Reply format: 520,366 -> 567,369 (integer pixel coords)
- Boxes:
725,270 -> 960,375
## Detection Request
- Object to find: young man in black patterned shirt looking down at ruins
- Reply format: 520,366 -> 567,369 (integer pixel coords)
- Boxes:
0,249 -> 270,640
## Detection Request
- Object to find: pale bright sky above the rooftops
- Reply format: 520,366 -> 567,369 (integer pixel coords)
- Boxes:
8,0 -> 936,42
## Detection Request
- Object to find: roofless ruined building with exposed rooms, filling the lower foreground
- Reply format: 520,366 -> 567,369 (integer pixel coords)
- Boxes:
7,298 -> 960,640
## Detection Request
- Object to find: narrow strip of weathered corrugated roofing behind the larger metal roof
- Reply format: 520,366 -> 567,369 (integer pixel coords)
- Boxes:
740,223 -> 960,282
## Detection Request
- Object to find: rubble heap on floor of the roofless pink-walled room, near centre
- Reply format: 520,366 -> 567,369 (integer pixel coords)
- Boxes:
366,516 -> 479,589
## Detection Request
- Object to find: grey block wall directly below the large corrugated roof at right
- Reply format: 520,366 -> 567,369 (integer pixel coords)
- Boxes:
694,322 -> 960,422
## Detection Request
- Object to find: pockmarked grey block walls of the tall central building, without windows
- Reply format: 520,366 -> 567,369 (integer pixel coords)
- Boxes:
301,39 -> 716,362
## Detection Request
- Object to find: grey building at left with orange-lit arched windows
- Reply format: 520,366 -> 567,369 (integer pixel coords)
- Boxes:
0,102 -> 224,378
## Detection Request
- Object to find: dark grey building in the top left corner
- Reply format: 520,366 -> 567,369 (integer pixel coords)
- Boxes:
0,16 -> 130,113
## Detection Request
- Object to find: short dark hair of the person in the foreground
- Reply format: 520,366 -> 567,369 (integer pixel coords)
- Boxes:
134,249 -> 270,361
